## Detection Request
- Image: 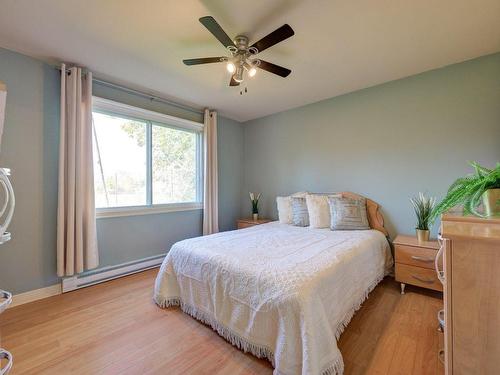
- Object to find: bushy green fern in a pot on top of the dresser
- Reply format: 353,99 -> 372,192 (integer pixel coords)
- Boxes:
431,162 -> 500,220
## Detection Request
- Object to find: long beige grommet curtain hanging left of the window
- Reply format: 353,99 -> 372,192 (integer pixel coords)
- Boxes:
57,64 -> 99,276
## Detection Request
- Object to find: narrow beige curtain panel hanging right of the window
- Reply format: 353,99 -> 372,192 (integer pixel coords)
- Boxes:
203,109 -> 219,235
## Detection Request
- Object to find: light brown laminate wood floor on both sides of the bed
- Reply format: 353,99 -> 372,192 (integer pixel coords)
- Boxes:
0,270 -> 443,375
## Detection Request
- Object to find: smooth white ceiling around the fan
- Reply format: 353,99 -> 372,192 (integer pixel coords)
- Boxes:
0,0 -> 500,121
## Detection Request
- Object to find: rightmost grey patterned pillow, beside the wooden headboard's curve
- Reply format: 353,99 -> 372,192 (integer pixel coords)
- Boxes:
328,197 -> 370,230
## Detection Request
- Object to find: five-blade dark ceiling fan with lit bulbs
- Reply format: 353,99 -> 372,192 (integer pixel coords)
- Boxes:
182,16 -> 295,86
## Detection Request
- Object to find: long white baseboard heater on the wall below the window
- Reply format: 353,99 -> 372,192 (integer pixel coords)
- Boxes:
62,254 -> 165,293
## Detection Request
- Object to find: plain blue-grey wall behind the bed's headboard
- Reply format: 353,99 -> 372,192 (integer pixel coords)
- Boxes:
242,53 -> 500,236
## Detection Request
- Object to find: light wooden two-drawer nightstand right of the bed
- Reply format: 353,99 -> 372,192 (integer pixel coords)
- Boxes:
393,236 -> 443,294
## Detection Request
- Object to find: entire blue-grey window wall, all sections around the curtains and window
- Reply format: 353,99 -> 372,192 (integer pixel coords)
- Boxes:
0,49 -> 243,293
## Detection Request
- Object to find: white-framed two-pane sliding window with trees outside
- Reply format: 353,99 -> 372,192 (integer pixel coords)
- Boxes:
92,97 -> 203,216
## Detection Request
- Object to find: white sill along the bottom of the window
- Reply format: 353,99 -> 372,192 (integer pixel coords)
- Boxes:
96,202 -> 203,219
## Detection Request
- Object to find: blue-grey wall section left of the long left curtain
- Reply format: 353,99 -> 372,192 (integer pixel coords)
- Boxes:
0,49 -> 60,293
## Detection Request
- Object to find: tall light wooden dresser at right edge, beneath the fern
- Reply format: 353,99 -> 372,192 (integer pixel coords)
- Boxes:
439,215 -> 500,375
